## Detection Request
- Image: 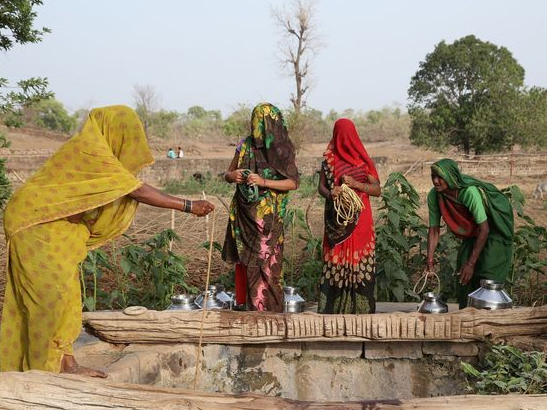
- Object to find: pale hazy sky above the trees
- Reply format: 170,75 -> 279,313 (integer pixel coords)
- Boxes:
4,0 -> 547,115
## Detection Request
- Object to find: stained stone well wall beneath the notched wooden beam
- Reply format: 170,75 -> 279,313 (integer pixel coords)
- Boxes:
75,342 -> 480,401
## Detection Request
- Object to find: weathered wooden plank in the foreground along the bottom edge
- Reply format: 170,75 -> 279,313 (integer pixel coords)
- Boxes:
0,371 -> 547,410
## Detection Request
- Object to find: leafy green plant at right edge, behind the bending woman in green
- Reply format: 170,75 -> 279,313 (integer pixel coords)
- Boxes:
502,185 -> 547,306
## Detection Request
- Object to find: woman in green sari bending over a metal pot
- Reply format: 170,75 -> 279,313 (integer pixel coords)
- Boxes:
427,159 -> 513,308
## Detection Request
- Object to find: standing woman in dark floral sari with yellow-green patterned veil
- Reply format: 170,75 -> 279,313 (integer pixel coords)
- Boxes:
222,103 -> 299,312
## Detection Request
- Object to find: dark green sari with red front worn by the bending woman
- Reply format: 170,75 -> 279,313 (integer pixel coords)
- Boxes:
428,159 -> 514,308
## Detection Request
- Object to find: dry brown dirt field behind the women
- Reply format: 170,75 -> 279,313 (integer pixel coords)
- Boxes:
0,132 -> 547,316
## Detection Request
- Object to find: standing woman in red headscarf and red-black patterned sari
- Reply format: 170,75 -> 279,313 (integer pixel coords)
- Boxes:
318,118 -> 380,313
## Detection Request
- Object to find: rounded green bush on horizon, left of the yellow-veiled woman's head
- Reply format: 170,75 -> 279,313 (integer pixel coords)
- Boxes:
29,99 -> 77,133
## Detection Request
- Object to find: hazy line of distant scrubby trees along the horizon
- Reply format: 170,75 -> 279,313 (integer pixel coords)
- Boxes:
3,98 -> 410,153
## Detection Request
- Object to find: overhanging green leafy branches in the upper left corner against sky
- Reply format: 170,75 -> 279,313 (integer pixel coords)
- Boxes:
0,0 -> 53,114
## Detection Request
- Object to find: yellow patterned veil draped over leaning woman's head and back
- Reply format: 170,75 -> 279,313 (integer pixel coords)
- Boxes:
4,106 -> 154,249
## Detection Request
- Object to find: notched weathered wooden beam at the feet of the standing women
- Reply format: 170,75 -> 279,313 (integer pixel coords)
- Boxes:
84,305 -> 547,344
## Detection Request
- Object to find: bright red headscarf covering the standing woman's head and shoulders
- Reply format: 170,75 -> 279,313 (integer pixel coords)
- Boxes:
324,118 -> 379,180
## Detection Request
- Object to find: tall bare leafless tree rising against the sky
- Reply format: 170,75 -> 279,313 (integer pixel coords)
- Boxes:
272,0 -> 322,115
